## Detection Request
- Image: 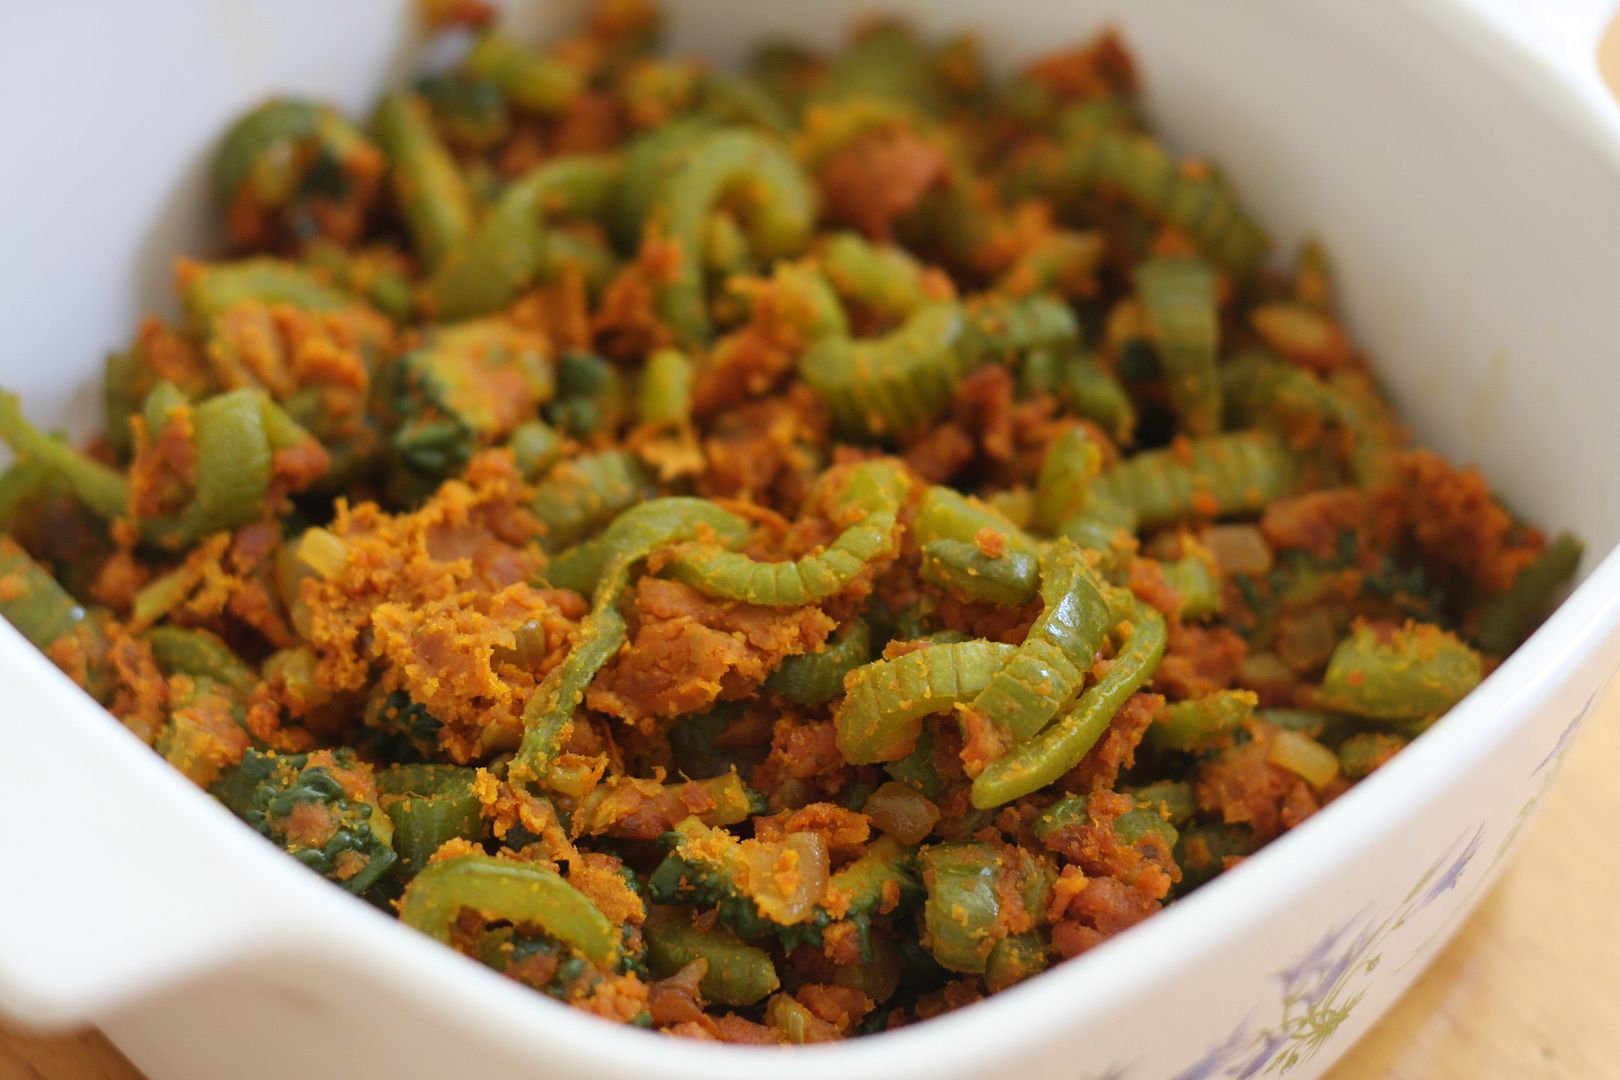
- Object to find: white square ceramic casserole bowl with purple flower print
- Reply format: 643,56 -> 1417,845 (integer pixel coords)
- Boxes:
0,0 -> 1620,1080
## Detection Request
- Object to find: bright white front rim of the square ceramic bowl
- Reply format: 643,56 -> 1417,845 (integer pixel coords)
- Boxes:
0,0 -> 1620,1080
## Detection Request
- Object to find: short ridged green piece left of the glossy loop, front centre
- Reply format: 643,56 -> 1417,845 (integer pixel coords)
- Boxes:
833,641 -> 1017,764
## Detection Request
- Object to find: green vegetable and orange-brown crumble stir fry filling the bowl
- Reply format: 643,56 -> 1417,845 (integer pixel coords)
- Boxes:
0,0 -> 1581,1043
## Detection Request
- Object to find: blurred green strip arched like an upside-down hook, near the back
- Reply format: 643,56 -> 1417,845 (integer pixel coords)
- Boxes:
650,131 -> 815,343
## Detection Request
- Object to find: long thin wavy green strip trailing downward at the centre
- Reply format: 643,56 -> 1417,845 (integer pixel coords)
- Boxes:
512,497 -> 747,779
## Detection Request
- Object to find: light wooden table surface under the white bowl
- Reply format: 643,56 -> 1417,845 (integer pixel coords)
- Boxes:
0,680 -> 1620,1080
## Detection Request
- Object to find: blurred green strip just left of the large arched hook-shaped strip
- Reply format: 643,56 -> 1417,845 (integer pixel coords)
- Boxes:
421,155 -> 619,319
